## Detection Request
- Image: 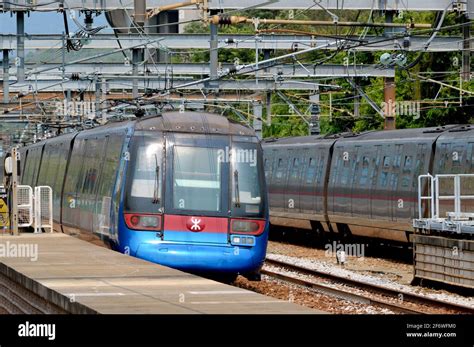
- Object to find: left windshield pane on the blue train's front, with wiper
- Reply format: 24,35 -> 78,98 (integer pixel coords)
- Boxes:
124,131 -> 164,213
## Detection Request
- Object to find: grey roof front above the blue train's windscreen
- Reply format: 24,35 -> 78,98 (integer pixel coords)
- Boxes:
136,112 -> 255,136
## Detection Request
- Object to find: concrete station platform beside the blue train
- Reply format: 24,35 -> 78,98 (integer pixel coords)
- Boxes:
0,233 -> 324,314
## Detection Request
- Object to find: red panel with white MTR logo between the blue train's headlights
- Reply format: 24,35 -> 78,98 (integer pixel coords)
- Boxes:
164,215 -> 229,233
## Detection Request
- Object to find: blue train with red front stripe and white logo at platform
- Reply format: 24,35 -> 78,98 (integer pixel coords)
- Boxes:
20,112 -> 269,280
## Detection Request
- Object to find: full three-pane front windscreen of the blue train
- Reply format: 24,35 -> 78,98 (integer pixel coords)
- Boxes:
125,132 -> 266,224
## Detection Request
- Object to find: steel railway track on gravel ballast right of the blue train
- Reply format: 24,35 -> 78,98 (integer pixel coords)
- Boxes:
262,259 -> 474,314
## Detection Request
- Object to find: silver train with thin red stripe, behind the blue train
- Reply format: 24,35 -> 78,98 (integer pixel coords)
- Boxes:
263,125 -> 474,243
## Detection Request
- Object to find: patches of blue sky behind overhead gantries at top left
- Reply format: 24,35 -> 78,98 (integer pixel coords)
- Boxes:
0,12 -> 107,34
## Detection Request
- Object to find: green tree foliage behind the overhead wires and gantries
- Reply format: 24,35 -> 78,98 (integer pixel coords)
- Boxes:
179,10 -> 474,137
